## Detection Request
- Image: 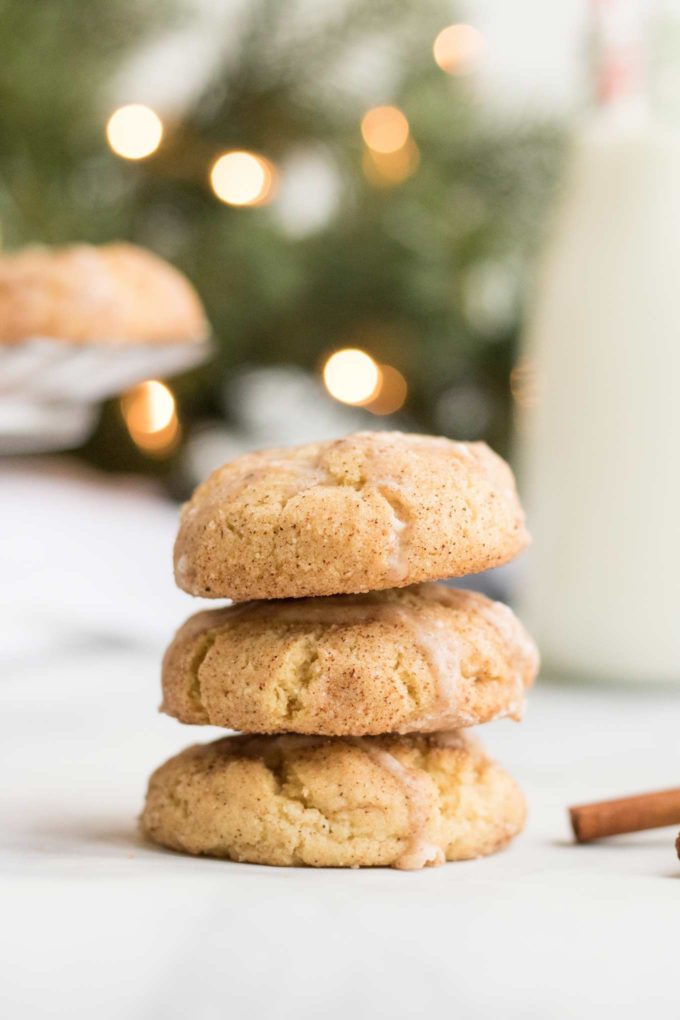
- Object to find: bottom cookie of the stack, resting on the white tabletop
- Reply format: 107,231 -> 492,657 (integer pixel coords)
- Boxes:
142,732 -> 525,869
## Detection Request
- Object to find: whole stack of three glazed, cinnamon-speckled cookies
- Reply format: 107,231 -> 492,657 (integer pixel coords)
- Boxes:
142,432 -> 537,869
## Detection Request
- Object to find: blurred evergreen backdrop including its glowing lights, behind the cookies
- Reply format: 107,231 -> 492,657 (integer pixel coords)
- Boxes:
0,0 -> 574,485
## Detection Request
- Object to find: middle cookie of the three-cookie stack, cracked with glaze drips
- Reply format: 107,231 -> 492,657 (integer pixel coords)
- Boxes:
162,582 -> 538,736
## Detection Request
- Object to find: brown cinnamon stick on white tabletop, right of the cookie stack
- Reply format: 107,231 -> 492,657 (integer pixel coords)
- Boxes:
569,787 -> 680,840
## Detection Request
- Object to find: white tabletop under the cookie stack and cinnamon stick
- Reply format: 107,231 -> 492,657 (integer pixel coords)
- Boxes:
0,465 -> 680,1020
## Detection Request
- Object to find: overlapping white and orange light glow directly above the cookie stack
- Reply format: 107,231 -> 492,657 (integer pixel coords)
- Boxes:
322,347 -> 408,415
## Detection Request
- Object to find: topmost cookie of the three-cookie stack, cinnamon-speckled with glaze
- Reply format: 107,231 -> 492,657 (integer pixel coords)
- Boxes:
174,432 -> 528,601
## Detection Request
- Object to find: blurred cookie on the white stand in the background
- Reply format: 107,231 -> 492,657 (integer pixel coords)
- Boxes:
0,243 -> 208,344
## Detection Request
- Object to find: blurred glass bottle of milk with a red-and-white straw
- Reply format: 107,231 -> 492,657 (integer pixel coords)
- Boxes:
519,0 -> 680,685
